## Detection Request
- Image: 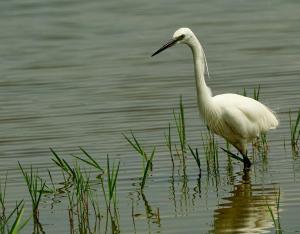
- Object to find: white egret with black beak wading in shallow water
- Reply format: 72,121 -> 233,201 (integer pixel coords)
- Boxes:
152,28 -> 278,168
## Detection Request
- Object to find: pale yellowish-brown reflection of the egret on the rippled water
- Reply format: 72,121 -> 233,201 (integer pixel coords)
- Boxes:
213,172 -> 278,233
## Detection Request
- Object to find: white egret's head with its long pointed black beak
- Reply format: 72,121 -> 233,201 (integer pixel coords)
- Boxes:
152,28 -> 195,56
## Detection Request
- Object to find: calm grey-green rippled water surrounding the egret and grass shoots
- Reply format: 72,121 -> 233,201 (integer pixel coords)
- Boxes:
0,0 -> 300,233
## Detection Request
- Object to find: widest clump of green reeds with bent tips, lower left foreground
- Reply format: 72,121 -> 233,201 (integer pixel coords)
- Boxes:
51,148 -> 120,233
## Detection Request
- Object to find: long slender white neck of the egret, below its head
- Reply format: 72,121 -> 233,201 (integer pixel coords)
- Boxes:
188,37 -> 212,115
